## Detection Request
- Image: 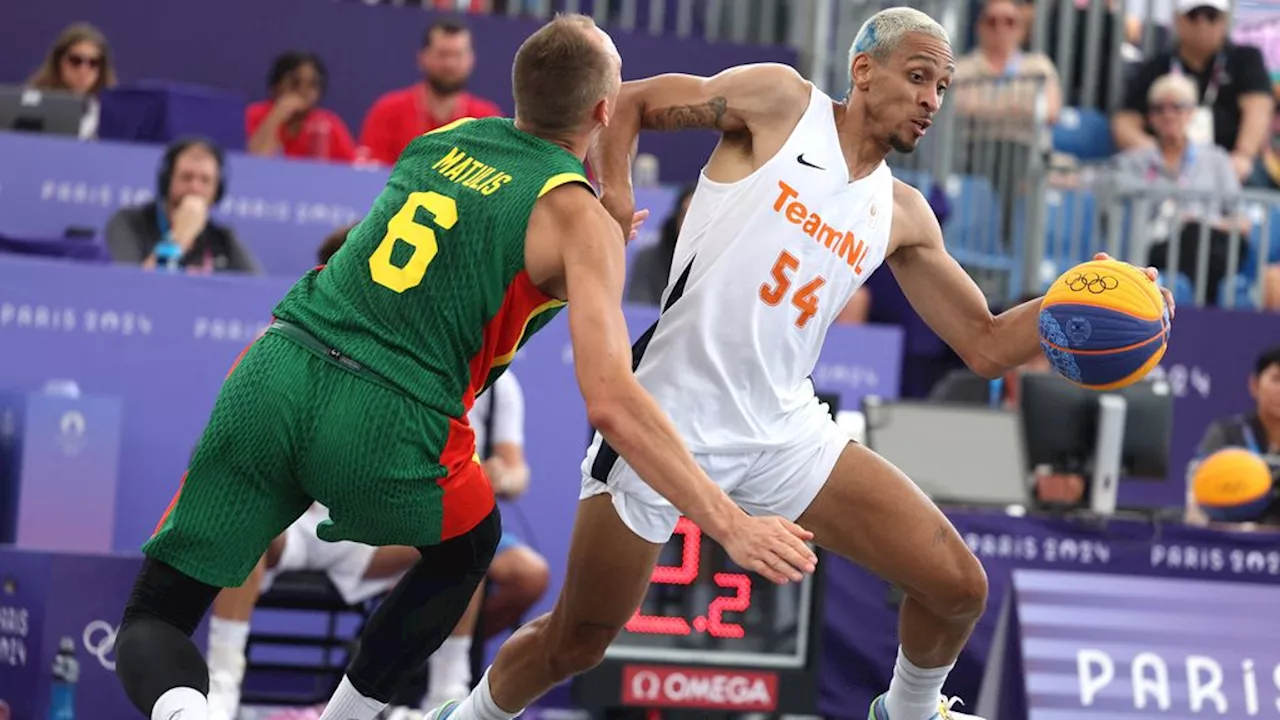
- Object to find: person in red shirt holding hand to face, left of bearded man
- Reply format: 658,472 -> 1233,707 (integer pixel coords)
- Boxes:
244,53 -> 356,163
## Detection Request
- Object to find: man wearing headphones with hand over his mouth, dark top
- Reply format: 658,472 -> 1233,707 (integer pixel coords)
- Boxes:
106,138 -> 260,274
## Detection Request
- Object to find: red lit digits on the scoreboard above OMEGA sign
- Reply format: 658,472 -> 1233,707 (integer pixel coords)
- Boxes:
626,518 -> 751,638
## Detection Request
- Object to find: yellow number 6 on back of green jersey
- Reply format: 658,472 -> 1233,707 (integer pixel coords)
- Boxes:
369,192 -> 458,292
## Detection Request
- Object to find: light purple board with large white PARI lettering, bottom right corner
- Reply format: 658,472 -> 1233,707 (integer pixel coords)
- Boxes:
979,570 -> 1280,720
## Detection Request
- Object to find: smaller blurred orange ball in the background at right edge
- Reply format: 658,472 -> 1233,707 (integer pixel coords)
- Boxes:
1192,447 -> 1272,523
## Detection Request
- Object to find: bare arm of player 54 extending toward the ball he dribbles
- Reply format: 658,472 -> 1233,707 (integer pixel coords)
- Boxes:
888,181 -> 1041,378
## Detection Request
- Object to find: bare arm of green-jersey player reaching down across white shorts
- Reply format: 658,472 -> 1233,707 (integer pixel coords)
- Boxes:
531,188 -> 817,582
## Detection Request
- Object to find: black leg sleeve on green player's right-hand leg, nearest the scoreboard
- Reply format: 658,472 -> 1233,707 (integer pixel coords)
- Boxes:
347,507 -> 502,702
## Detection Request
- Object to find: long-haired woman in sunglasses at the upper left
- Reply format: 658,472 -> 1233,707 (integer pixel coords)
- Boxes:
27,23 -> 115,140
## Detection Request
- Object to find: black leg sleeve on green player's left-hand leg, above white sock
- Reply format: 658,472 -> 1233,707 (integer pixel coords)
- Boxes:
115,559 -> 219,716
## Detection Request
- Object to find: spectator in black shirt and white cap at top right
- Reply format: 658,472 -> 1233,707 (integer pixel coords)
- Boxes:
1111,0 -> 1275,184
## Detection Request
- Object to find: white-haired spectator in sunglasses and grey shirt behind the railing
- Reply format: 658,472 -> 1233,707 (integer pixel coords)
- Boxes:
1115,74 -> 1251,305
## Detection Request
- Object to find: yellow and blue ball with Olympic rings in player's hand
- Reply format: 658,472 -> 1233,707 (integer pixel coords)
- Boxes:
1039,260 -> 1169,389
